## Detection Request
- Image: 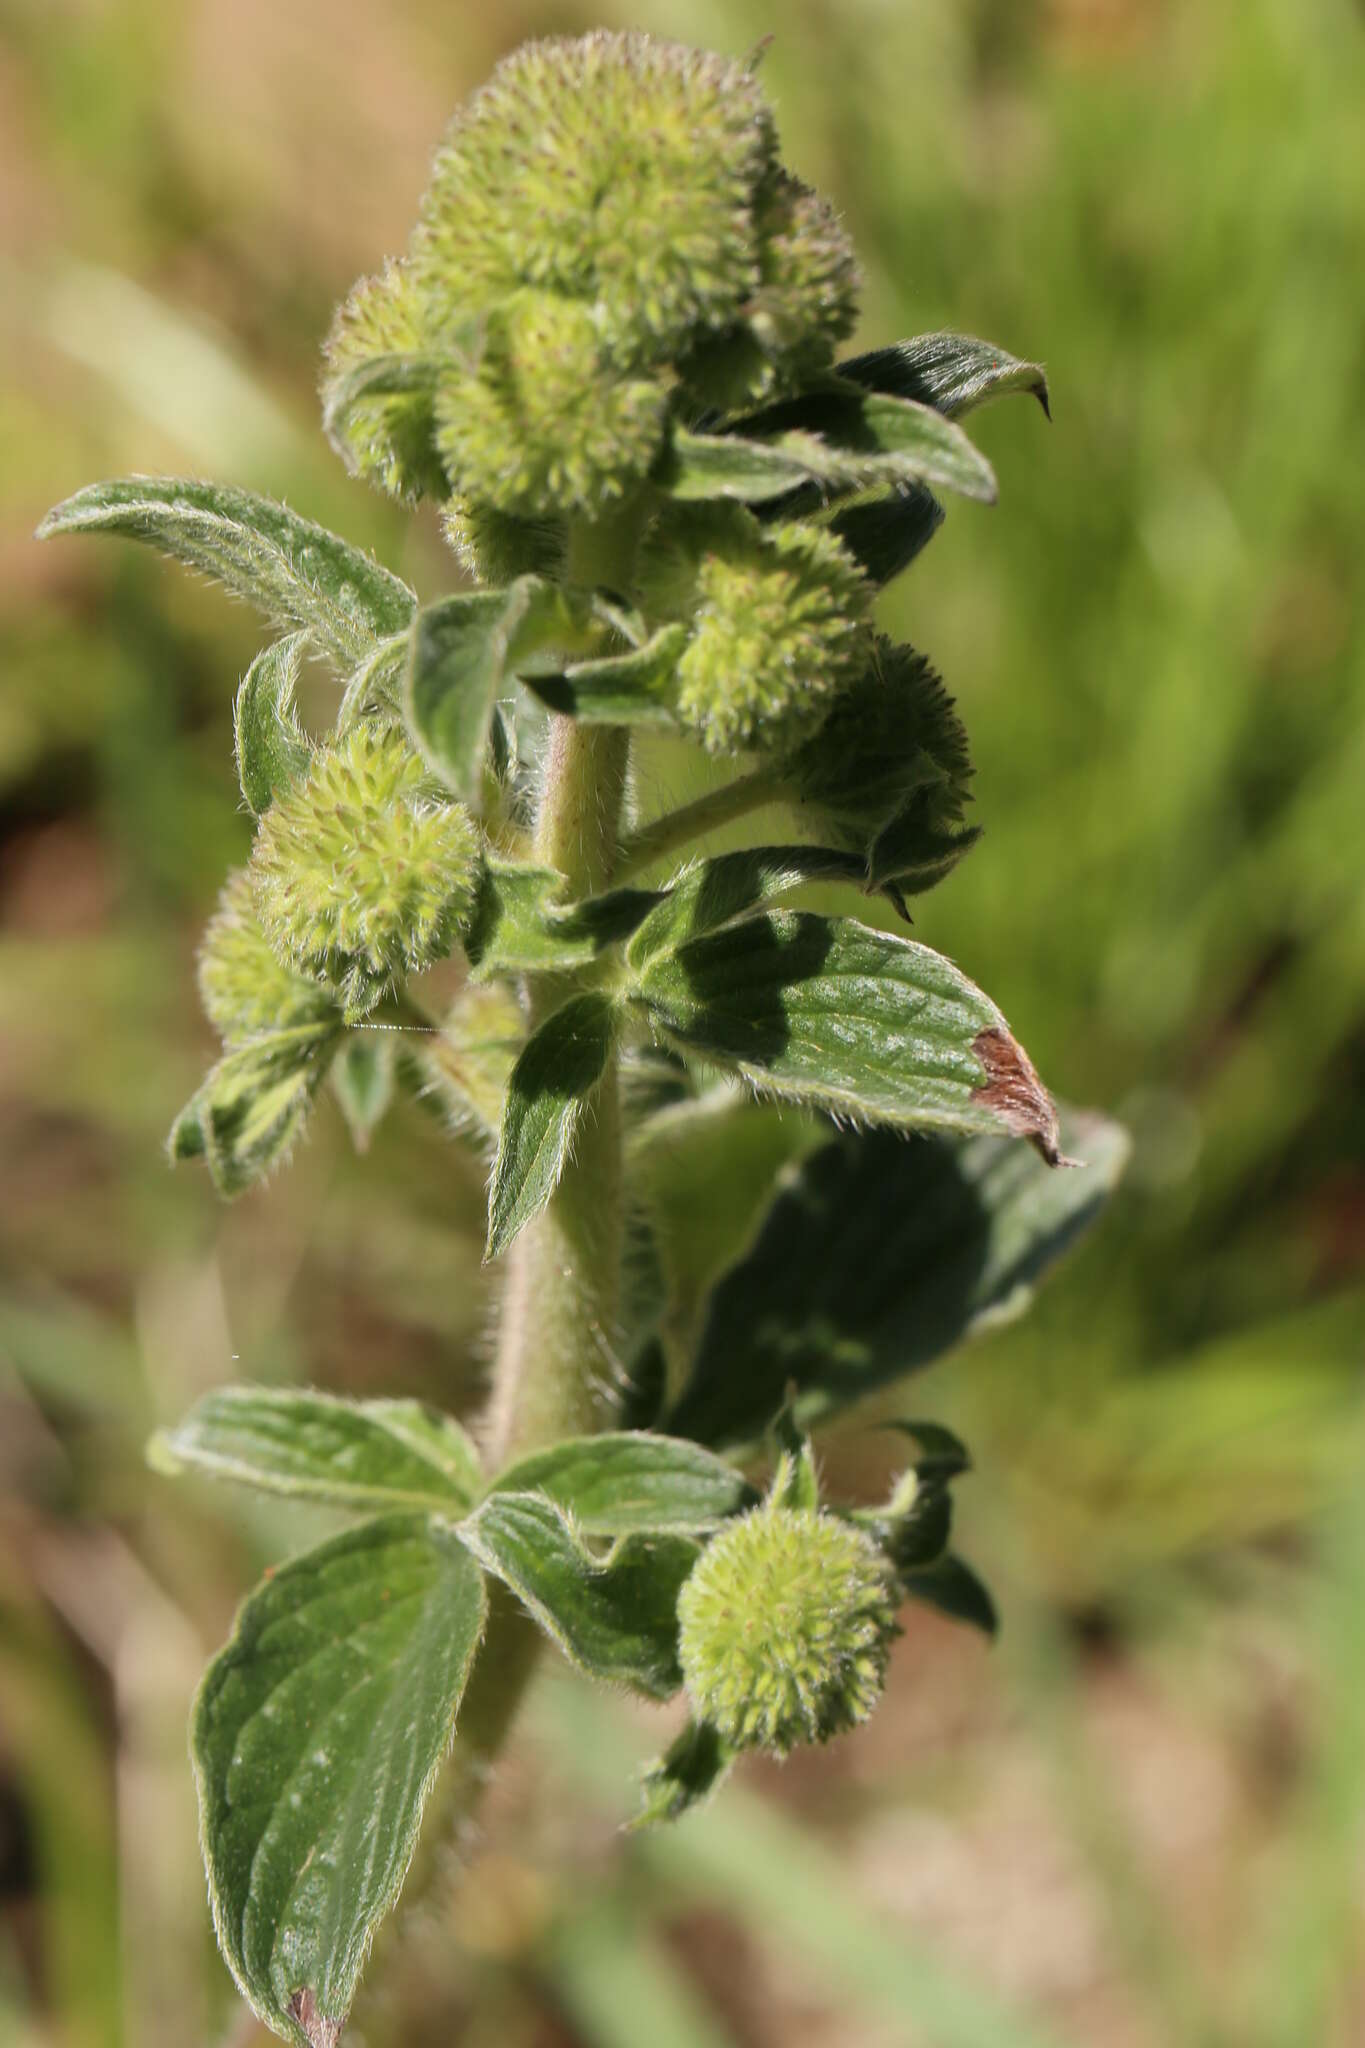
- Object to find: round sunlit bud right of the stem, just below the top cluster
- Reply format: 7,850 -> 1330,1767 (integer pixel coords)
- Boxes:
655,506 -> 872,754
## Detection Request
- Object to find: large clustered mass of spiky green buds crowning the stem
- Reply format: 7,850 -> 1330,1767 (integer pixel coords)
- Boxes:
325,31 -> 857,520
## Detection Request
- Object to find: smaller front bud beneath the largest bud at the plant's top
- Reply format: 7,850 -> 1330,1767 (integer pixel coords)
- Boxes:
436,291 -> 667,520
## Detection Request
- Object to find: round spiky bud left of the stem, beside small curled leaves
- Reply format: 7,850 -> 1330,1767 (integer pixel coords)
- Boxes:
250,725 -> 479,1018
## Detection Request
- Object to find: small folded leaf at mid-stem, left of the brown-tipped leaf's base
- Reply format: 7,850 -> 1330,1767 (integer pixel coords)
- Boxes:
460,860 -> 661,979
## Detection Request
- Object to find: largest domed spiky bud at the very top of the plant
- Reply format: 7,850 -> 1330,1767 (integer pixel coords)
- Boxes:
413,31 -> 772,362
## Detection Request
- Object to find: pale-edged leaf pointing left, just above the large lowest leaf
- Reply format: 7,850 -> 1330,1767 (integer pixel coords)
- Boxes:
147,1386 -> 483,1513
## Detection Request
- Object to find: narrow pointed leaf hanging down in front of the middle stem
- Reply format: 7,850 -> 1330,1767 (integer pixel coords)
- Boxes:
485,993 -> 616,1260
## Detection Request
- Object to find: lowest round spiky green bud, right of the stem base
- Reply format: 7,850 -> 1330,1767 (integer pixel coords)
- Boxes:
677,1501 -> 896,1757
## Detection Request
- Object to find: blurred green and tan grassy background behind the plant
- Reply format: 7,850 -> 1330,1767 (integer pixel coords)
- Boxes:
0,0 -> 1365,2048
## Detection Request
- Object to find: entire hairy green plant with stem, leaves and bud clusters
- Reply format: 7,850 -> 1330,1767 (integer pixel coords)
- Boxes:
31,19 -> 1121,2048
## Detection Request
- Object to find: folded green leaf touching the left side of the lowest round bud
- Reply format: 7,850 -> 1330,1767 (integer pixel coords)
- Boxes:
458,1493 -> 700,1700
